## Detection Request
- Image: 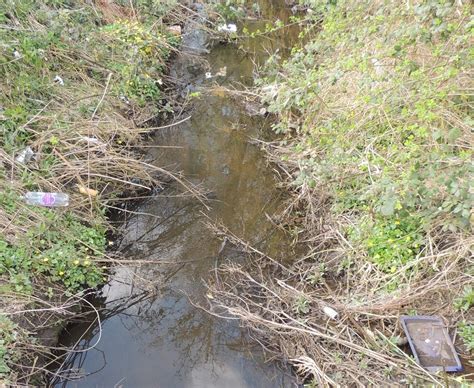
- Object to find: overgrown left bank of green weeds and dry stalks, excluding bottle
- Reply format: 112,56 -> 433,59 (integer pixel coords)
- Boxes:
0,0 -> 198,385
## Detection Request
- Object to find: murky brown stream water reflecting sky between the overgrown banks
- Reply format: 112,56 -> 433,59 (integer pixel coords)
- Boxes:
54,1 -> 297,387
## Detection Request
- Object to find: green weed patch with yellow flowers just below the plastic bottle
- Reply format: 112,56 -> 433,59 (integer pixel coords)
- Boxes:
0,189 -> 106,293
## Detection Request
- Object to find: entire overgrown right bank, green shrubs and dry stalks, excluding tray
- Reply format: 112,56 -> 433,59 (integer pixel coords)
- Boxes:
210,0 -> 474,386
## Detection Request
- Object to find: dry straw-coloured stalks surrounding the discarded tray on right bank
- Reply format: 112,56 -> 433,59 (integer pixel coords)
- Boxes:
209,221 -> 473,387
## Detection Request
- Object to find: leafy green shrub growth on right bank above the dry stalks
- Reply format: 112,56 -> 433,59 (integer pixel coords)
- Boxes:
259,0 -> 474,292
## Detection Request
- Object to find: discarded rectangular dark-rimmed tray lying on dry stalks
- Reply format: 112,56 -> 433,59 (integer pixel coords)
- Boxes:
400,315 -> 463,372
